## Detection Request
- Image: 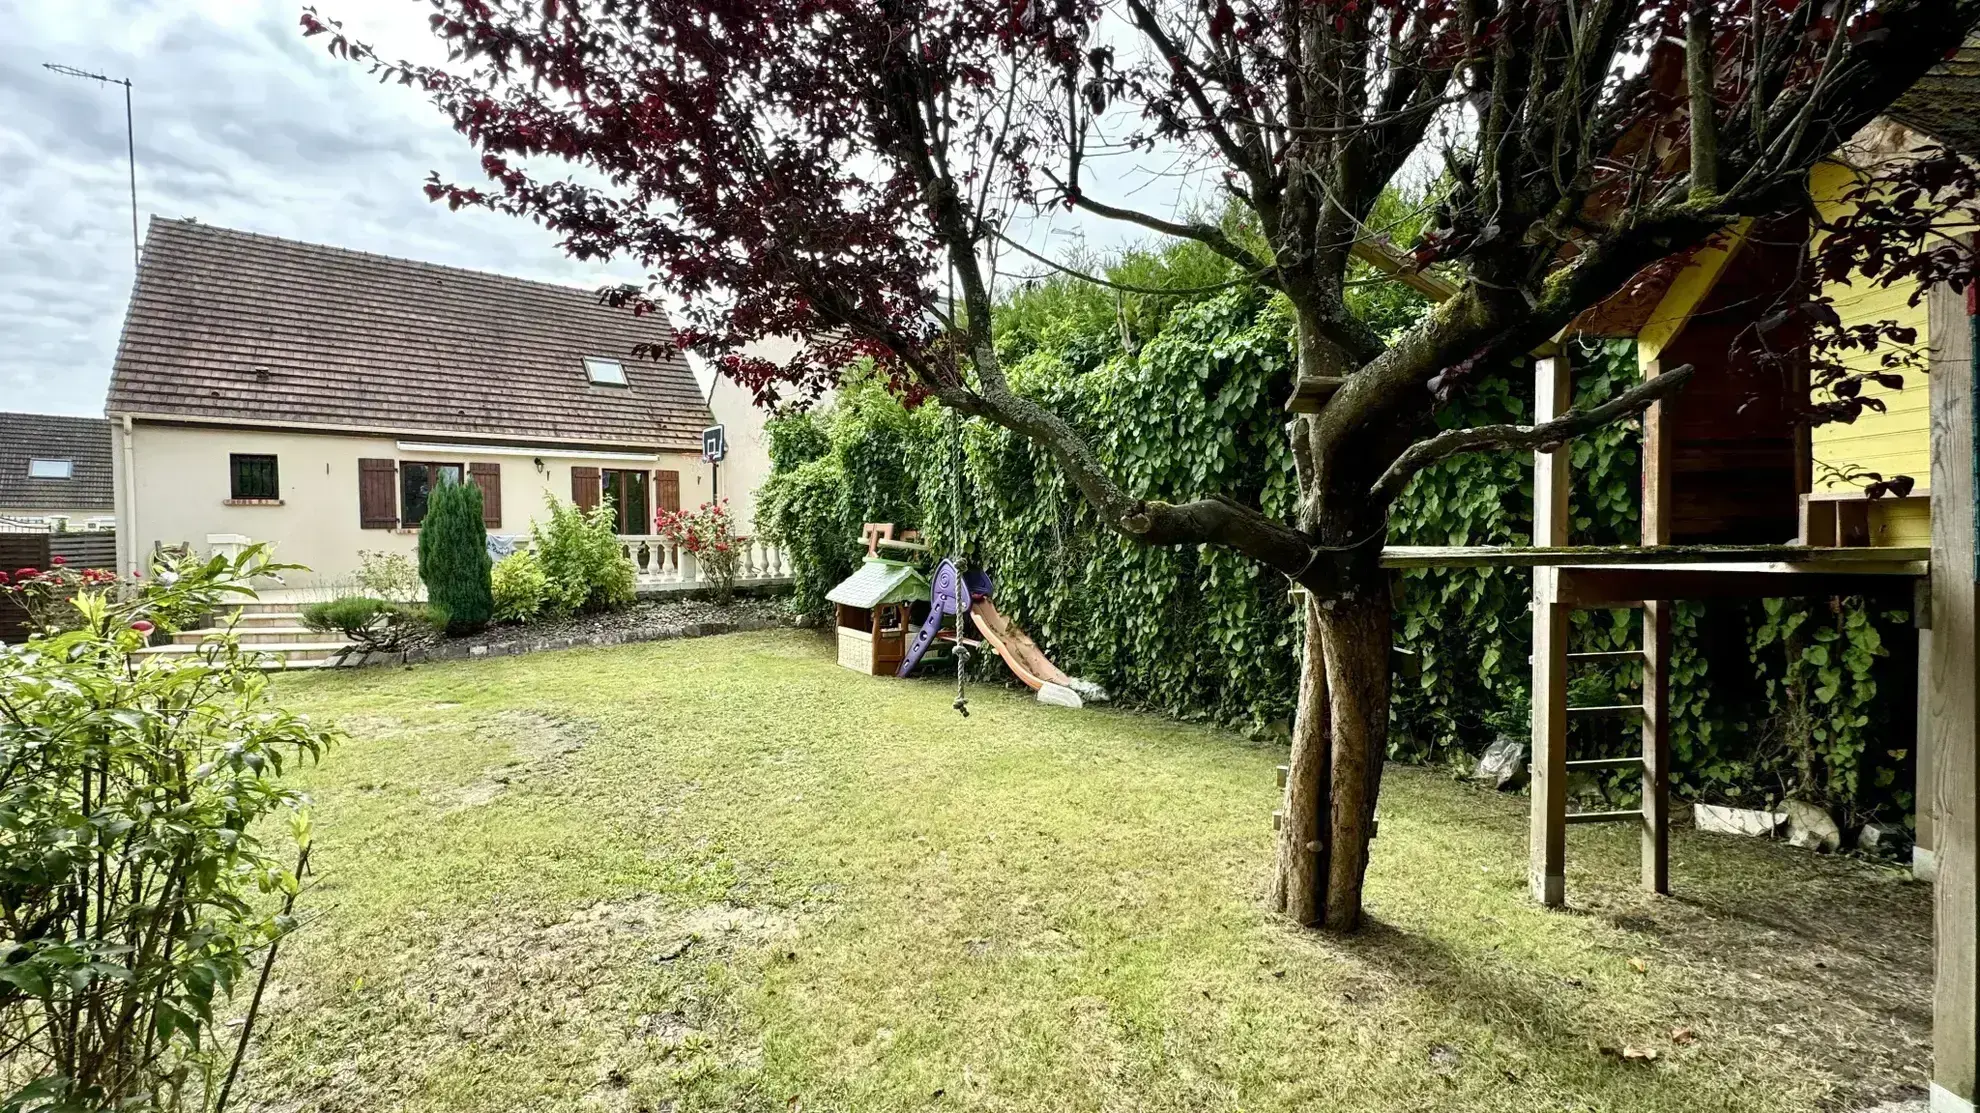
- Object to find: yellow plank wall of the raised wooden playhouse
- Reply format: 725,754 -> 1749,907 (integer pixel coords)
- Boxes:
1808,162 -> 1932,499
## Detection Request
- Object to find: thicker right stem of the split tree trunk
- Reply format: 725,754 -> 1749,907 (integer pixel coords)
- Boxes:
1317,572 -> 1390,931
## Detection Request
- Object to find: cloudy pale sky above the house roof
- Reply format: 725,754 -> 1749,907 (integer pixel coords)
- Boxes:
0,0 -> 1174,414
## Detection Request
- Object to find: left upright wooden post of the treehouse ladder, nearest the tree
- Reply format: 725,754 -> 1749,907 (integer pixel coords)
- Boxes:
1528,351 -> 1574,907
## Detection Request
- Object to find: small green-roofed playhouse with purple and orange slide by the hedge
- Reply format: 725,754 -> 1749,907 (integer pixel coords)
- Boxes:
826,523 -> 1107,713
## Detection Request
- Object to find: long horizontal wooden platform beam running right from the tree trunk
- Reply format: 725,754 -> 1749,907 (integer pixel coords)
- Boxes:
1382,542 -> 1932,576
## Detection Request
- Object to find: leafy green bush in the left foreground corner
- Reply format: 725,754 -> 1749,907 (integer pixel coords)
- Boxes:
0,547 -> 335,1113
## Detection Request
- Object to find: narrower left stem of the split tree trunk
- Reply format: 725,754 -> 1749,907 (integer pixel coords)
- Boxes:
1271,596 -> 1335,927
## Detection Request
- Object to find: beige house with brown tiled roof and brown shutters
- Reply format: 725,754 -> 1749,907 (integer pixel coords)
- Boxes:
105,218 -> 752,584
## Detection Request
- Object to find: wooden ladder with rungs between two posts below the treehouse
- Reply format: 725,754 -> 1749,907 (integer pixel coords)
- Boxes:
1529,349 -> 1671,905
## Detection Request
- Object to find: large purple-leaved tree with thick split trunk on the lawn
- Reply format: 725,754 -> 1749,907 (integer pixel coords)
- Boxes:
303,0 -> 1980,929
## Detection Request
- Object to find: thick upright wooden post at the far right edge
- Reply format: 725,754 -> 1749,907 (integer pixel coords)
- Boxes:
1927,279 -> 1980,1111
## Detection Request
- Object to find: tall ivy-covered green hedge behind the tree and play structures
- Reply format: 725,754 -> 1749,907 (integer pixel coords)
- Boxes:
758,248 -> 1915,820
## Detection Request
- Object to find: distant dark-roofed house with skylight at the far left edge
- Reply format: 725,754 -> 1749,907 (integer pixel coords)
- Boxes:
0,414 -> 117,529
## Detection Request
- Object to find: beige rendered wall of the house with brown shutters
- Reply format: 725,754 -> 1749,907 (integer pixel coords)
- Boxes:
115,422 -> 711,584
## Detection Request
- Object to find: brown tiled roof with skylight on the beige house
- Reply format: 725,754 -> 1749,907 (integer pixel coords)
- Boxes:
107,218 -> 709,452
